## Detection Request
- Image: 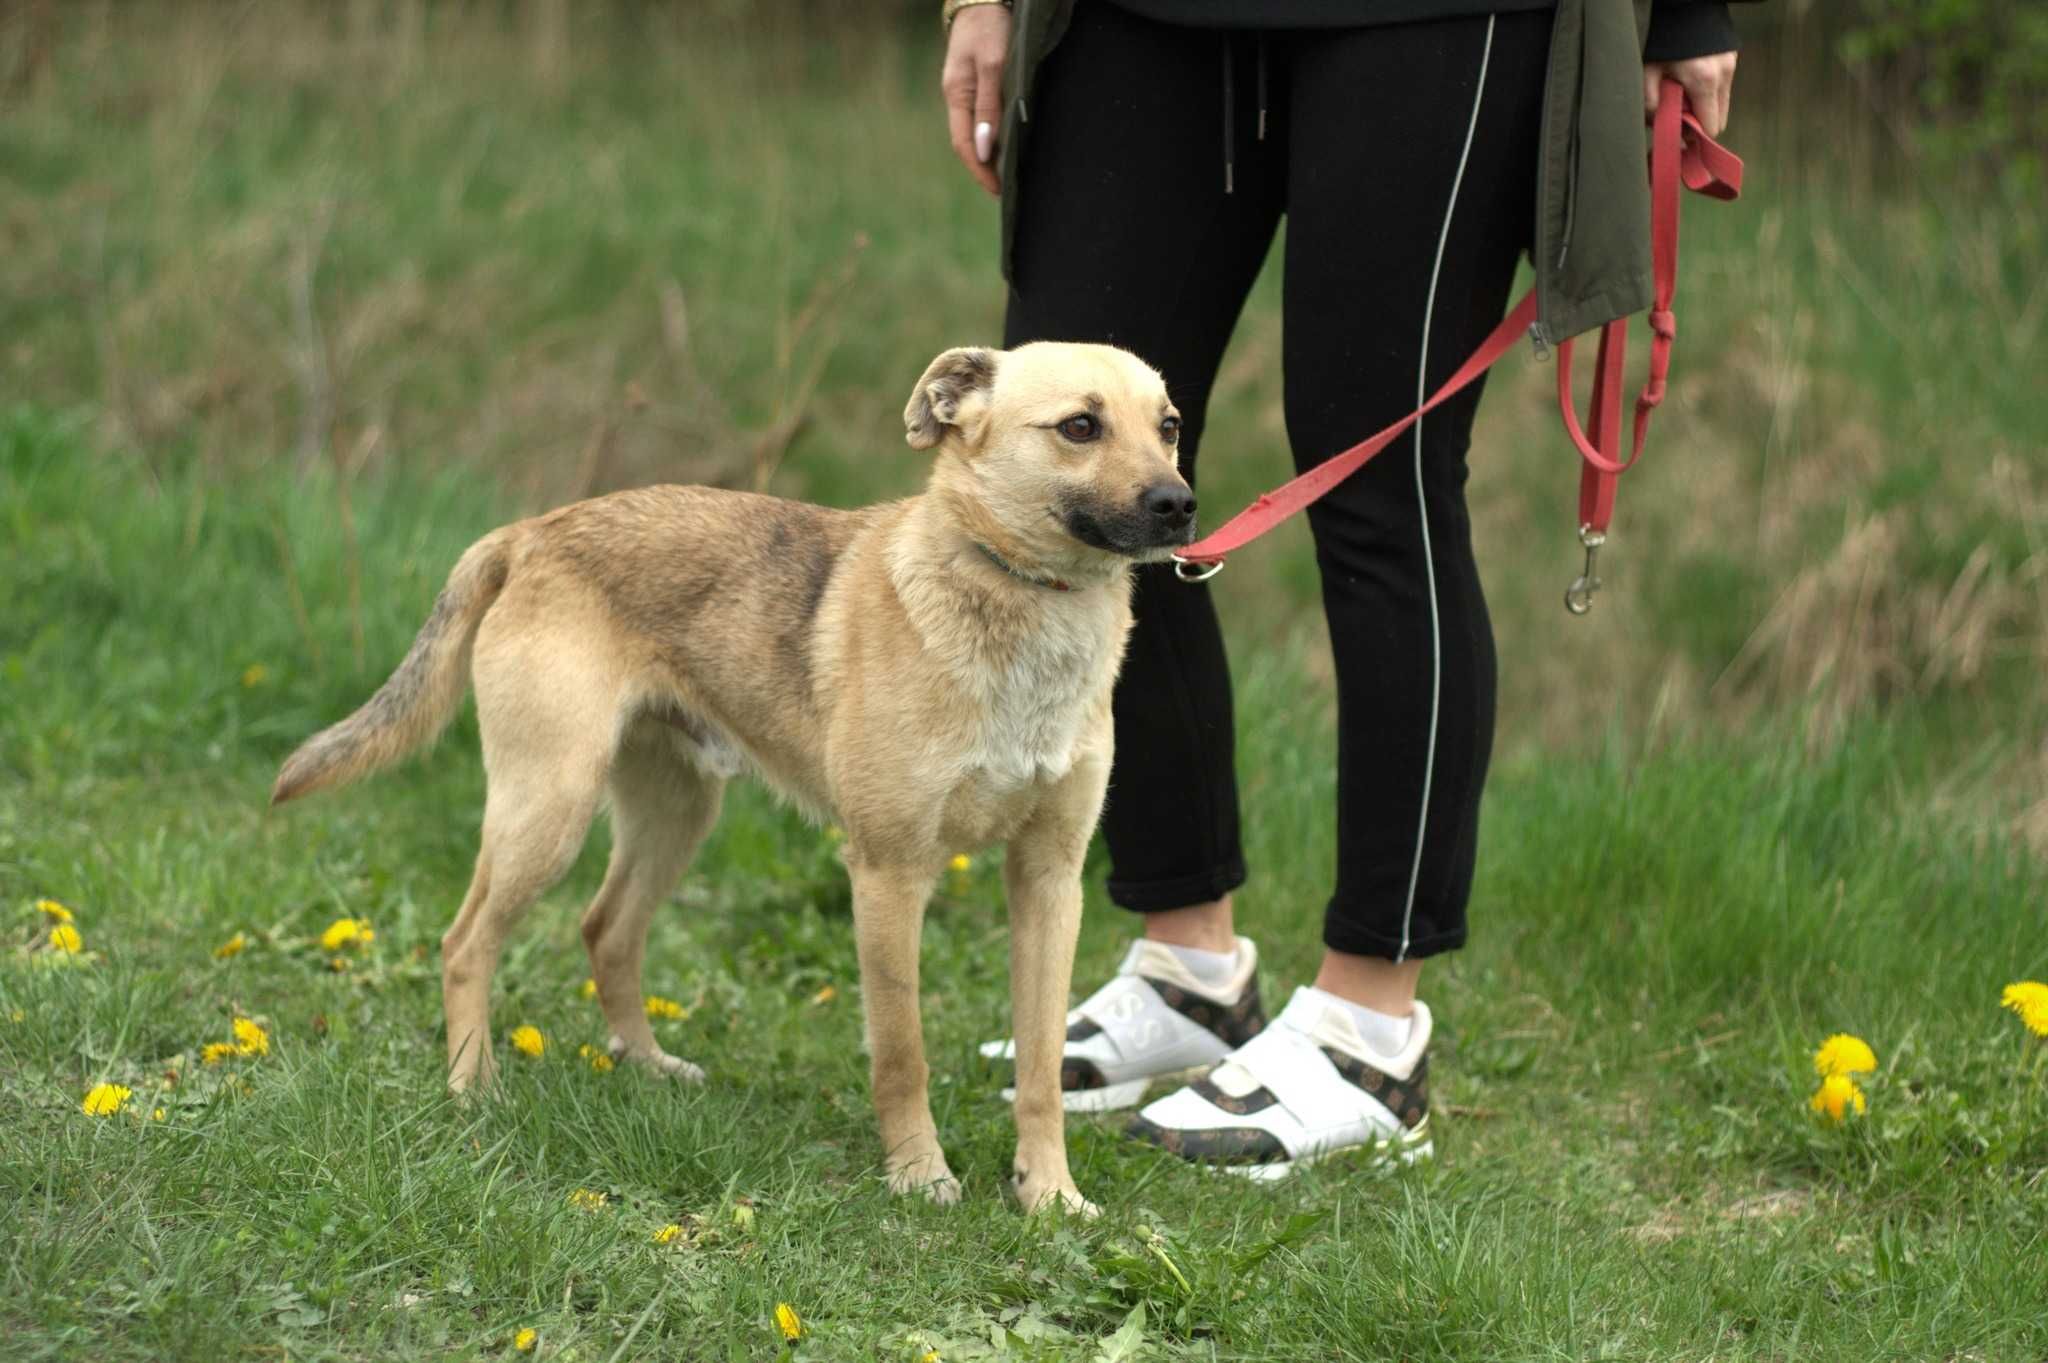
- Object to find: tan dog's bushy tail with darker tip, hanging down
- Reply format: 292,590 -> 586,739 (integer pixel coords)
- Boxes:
270,517 -> 518,804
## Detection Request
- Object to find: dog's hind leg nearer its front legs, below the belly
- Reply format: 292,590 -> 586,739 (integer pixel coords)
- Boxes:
584,731 -> 725,1081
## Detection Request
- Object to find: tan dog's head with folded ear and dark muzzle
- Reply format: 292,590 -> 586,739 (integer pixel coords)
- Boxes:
903,342 -> 1194,569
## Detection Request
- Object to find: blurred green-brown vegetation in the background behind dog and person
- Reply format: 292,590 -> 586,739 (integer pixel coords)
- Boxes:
0,0 -> 2048,847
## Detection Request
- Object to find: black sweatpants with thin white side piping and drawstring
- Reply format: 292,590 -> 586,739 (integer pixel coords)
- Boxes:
1006,0 -> 1550,960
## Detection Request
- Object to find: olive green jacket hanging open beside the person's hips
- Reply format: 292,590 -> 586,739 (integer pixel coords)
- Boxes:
1001,0 -> 1651,342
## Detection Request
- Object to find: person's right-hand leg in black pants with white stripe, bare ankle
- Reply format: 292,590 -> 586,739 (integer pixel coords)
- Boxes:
1284,14 -> 1550,1017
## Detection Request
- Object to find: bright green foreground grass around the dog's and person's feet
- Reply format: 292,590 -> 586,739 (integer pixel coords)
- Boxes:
0,411 -> 2048,1359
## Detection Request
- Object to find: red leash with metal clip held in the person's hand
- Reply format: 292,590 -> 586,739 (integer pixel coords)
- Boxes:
1174,80 -> 1743,616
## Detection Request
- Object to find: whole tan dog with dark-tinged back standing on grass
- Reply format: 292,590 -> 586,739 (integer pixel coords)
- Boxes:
272,344 -> 1194,1210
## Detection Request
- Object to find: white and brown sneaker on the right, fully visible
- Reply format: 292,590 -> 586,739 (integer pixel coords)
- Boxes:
1128,988 -> 1432,1179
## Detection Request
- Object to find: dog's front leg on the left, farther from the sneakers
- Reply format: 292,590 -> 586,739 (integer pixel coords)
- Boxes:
846,847 -> 961,1203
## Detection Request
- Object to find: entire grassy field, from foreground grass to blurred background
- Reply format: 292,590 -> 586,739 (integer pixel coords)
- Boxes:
0,0 -> 2048,1363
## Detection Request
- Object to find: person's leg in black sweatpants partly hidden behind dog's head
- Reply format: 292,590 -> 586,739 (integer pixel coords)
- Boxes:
1004,4 -> 1284,933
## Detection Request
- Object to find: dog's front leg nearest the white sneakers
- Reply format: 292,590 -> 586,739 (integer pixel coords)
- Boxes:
1004,796 -> 1100,1216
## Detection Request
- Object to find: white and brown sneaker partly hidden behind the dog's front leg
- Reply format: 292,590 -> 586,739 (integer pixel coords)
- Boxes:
981,937 -> 1266,1111
